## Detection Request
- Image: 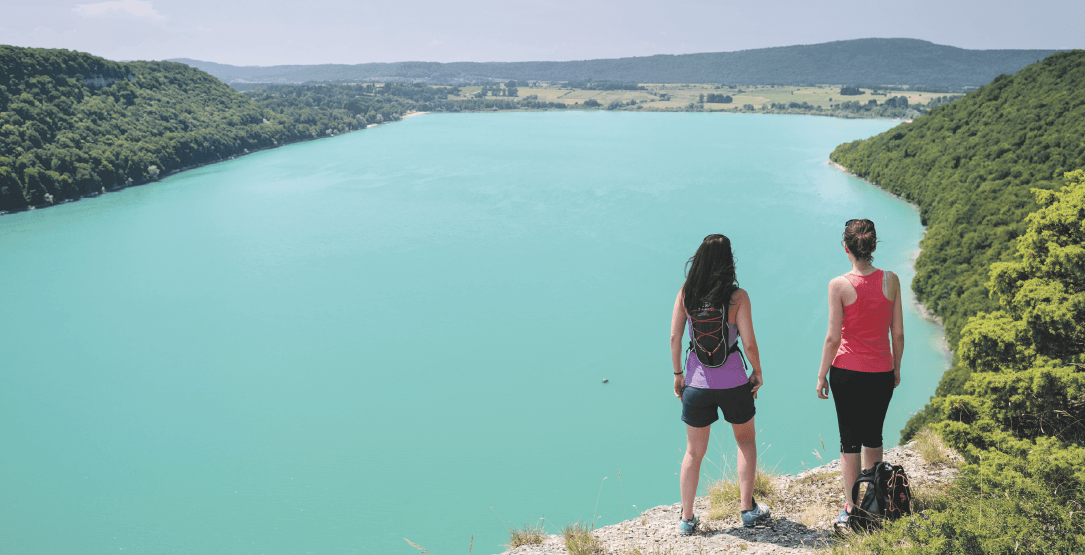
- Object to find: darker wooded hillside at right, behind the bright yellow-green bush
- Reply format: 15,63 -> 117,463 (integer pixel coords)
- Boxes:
831,51 -> 1085,405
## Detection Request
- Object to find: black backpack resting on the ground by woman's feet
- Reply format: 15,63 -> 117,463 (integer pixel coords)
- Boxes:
847,461 -> 911,531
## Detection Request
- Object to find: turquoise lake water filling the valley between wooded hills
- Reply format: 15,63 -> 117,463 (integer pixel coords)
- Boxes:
0,112 -> 947,555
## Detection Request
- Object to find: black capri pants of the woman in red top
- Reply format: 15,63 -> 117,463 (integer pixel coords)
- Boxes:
829,366 -> 894,453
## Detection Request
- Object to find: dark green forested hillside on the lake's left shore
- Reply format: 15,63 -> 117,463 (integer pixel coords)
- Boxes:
0,46 -> 359,211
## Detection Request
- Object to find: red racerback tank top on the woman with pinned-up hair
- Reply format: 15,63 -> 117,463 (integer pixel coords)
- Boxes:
832,270 -> 893,372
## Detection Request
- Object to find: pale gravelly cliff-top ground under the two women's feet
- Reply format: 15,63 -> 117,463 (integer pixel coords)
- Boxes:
502,443 -> 957,555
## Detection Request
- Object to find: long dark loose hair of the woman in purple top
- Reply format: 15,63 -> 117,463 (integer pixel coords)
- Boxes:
681,233 -> 739,312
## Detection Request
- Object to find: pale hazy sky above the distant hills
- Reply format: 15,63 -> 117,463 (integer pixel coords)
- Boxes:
0,0 -> 1085,65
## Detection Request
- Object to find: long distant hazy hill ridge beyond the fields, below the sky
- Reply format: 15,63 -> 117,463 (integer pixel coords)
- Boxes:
171,39 -> 1057,90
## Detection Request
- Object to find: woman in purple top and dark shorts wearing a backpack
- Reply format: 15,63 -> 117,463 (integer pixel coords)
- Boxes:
671,235 -> 769,535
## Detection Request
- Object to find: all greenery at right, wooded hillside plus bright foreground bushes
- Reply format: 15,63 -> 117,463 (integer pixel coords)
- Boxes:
832,51 -> 1085,554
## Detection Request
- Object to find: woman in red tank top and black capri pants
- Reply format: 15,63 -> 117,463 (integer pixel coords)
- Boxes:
817,219 -> 904,524
